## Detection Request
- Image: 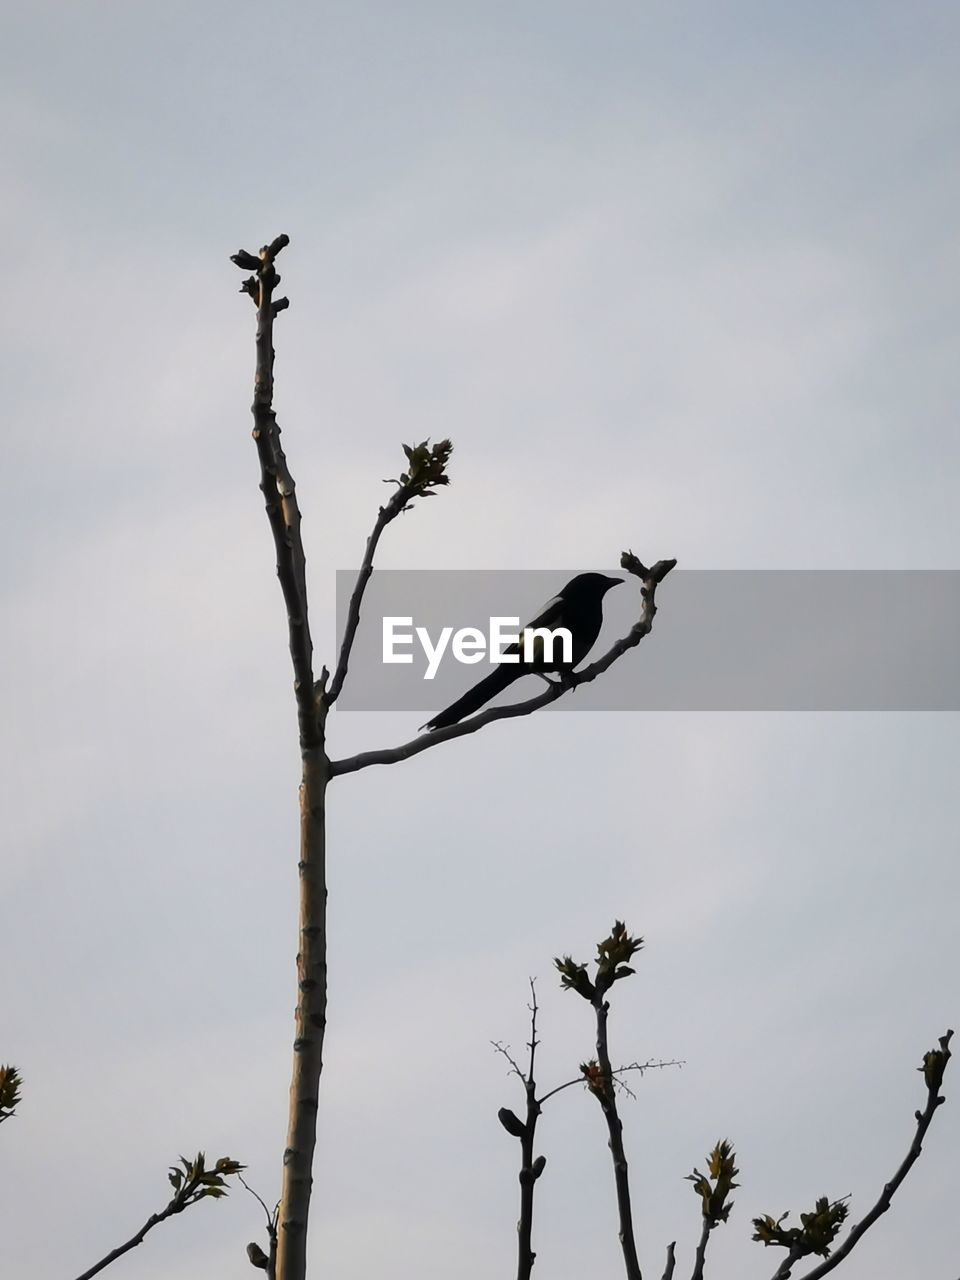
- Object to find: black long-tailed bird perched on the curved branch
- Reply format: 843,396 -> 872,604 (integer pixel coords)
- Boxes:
421,573 -> 623,732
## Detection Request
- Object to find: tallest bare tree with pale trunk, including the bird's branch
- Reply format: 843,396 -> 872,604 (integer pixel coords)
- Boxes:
232,236 -> 676,1280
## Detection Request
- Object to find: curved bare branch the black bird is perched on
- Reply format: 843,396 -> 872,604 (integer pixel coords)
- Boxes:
330,552 -> 677,778
